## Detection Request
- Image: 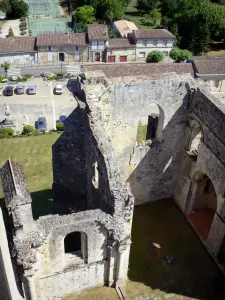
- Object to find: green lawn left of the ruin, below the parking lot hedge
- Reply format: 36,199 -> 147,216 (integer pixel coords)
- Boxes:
0,133 -> 59,218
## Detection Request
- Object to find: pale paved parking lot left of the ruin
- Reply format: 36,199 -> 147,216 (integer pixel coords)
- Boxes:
0,78 -> 77,131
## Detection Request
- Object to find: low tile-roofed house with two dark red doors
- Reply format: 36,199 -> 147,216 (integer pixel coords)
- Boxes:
106,38 -> 135,63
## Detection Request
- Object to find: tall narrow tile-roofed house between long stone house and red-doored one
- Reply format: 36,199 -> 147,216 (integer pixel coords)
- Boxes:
88,24 -> 109,62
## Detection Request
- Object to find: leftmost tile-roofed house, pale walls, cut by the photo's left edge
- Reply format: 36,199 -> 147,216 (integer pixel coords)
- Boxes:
0,37 -> 37,65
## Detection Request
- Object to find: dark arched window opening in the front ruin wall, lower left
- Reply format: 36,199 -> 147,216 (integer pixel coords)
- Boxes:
64,231 -> 87,263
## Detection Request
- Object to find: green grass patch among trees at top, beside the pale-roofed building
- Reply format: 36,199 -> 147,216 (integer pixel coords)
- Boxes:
124,0 -> 152,29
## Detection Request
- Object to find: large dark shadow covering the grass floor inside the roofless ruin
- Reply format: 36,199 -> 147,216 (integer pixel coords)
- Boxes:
128,199 -> 225,300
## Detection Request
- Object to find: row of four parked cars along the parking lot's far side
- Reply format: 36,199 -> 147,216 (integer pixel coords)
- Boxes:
0,84 -> 63,96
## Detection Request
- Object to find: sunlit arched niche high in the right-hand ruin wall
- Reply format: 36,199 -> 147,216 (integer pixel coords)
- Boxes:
188,119 -> 203,152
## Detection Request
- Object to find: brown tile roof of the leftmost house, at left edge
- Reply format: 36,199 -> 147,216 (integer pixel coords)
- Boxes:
0,37 -> 35,53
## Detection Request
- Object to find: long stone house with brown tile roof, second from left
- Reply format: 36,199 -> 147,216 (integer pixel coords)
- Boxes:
36,33 -> 88,64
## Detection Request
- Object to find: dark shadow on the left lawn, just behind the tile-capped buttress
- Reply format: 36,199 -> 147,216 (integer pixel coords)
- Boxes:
31,189 -> 53,219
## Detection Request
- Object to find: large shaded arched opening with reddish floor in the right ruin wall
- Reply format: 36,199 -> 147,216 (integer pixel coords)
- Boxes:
188,173 -> 217,240
